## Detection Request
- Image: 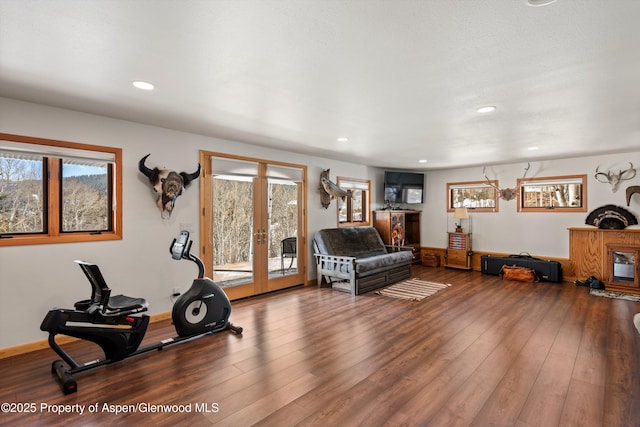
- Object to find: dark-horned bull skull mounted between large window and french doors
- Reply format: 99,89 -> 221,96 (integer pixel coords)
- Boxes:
138,154 -> 200,219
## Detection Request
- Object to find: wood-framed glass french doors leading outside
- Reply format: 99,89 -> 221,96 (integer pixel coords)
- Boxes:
200,152 -> 306,299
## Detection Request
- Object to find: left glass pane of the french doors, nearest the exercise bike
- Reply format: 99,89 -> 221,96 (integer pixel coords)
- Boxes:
211,171 -> 254,287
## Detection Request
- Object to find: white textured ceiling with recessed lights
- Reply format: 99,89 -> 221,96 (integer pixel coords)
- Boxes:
0,0 -> 640,169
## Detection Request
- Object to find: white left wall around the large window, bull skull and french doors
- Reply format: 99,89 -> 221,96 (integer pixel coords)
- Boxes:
0,98 -> 374,348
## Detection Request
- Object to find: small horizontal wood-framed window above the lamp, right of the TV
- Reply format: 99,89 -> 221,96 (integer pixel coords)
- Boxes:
447,181 -> 498,212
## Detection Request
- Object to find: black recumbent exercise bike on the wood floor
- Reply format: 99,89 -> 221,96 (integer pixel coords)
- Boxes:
40,231 -> 242,394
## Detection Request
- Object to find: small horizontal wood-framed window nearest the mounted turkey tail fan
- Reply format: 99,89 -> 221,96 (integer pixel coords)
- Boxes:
518,175 -> 587,212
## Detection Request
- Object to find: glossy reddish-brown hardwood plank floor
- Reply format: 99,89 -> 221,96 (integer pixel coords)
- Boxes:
0,266 -> 640,427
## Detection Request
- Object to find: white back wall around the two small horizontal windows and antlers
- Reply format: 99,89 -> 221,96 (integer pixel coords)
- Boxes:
421,156 -> 640,258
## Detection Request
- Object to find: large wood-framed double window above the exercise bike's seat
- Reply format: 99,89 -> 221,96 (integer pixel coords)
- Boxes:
0,134 -> 122,246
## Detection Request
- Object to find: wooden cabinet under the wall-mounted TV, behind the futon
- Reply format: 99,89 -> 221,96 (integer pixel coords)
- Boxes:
373,210 -> 422,263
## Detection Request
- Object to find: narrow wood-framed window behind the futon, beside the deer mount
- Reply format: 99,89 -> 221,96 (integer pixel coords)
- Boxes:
337,177 -> 371,227
